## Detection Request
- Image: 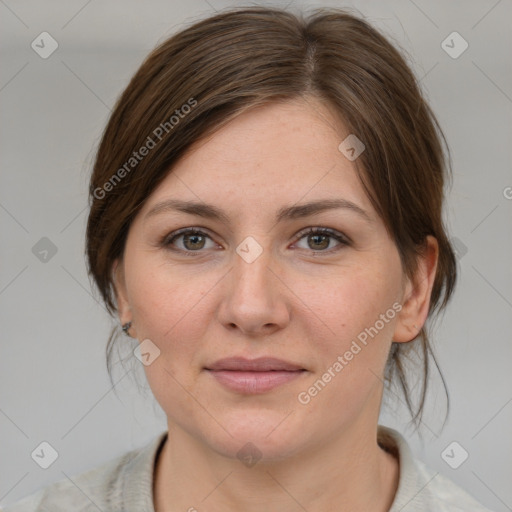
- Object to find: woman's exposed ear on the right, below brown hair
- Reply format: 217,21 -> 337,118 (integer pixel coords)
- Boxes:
393,236 -> 439,343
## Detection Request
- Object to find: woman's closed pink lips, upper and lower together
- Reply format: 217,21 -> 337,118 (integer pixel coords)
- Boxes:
205,357 -> 306,394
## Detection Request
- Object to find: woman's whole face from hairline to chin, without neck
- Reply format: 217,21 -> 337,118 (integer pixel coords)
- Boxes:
117,101 -> 426,459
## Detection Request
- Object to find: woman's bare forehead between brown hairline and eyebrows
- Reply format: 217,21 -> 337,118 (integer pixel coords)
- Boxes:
138,99 -> 373,219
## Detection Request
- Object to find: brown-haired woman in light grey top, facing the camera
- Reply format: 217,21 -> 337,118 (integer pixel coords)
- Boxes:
3,8 -> 487,512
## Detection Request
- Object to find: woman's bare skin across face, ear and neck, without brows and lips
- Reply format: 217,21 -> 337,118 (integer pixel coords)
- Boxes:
114,98 -> 437,512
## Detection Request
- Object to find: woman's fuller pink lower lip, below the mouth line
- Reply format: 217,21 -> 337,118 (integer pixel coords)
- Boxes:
208,370 -> 304,394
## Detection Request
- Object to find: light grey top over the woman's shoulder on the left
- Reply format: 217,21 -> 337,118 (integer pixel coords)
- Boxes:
0,432 -> 167,512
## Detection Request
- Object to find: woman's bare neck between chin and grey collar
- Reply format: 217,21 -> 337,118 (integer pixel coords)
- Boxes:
154,418 -> 399,512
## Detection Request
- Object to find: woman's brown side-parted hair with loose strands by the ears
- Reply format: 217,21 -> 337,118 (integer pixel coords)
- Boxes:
86,7 -> 457,428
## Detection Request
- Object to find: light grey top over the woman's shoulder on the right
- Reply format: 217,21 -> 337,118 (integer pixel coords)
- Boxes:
378,425 -> 492,512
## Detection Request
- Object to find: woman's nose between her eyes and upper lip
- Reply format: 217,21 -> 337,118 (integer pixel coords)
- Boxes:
214,242 -> 290,337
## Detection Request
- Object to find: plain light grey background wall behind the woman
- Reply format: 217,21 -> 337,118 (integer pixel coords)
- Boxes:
0,0 -> 512,511
